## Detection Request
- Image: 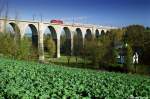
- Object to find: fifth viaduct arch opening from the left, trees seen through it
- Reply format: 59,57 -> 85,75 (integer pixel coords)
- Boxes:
73,28 -> 83,55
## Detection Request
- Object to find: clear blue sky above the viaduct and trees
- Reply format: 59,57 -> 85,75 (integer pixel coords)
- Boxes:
2,0 -> 150,27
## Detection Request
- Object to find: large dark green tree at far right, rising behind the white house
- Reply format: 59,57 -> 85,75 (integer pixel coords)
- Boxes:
126,25 -> 150,64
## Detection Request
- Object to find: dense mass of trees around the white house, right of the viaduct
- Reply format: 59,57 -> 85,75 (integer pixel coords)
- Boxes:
75,25 -> 150,72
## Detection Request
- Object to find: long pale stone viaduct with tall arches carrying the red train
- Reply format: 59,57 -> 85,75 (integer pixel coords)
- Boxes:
0,19 -> 115,61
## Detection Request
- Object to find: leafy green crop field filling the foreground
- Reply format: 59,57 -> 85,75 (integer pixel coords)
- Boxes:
0,58 -> 150,99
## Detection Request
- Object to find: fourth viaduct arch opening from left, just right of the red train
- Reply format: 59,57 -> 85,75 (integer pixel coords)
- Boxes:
60,27 -> 71,55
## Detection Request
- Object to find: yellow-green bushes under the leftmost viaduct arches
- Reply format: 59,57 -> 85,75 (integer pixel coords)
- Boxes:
0,33 -> 38,60
